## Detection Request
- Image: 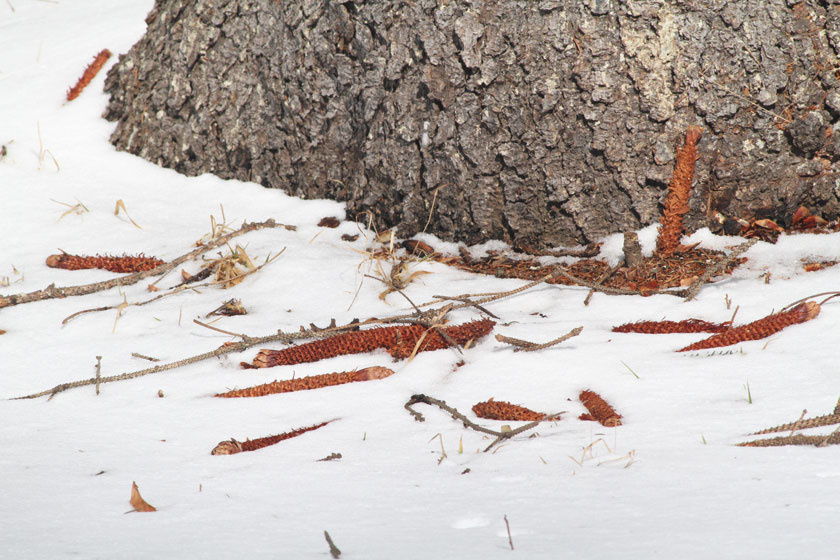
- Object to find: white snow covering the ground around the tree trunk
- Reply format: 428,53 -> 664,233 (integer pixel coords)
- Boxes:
0,0 -> 840,559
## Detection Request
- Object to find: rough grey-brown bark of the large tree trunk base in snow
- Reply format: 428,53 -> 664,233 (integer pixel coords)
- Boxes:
105,0 -> 840,246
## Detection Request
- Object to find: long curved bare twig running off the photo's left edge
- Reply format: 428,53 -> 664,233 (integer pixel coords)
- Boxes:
0,220 -> 294,308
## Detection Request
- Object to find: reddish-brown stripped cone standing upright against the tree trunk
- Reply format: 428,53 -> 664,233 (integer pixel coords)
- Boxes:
656,126 -> 703,255
